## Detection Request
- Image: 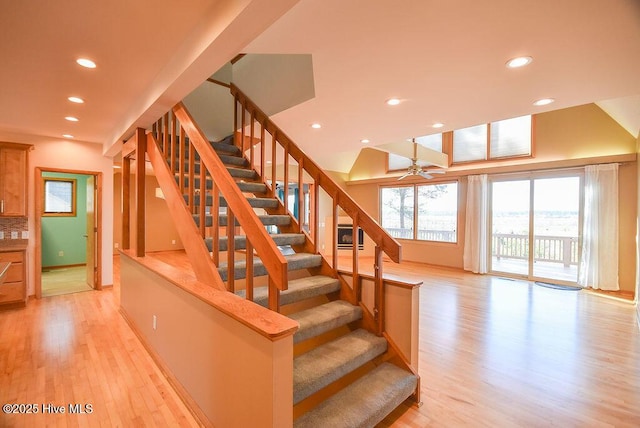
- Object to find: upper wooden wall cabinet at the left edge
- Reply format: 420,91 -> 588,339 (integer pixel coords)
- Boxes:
0,143 -> 31,217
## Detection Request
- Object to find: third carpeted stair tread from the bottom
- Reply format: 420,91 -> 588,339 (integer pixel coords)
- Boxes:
289,300 -> 362,343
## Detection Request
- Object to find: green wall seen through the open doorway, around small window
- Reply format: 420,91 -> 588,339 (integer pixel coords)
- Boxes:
42,172 -> 89,268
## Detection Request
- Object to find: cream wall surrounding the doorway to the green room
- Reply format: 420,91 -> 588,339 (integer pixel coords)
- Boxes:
27,138 -> 113,295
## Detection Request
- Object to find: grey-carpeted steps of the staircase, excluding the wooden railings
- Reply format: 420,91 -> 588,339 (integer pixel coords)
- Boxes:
185,138 -> 417,427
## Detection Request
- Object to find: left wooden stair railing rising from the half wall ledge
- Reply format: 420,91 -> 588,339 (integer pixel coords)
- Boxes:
151,103 -> 288,311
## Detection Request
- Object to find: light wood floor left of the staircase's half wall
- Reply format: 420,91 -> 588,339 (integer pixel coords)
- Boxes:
0,256 -> 197,427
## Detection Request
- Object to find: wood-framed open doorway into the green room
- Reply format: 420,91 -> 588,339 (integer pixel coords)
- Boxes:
35,168 -> 102,298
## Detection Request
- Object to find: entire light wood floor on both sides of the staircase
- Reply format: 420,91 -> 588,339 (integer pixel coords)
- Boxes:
0,254 -> 640,427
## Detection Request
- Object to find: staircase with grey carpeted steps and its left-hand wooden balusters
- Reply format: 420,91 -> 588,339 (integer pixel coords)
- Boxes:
141,88 -> 419,427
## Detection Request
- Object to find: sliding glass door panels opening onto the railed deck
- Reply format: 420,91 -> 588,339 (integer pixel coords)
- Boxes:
490,173 -> 582,285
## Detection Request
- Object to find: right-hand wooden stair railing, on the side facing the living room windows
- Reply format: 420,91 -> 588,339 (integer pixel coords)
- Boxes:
231,83 -> 401,334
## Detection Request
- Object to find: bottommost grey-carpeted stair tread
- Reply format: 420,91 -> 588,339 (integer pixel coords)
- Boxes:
293,363 -> 418,428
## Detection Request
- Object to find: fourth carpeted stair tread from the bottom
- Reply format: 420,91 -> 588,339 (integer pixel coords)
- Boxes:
236,275 -> 340,307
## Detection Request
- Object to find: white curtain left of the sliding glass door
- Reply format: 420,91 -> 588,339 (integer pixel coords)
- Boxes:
463,174 -> 489,273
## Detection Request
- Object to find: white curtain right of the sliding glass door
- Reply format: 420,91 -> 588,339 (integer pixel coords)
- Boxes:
578,164 -> 619,290
